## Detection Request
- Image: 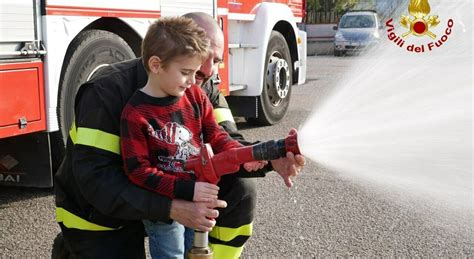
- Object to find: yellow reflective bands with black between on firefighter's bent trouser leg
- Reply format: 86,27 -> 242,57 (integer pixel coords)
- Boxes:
209,223 -> 253,259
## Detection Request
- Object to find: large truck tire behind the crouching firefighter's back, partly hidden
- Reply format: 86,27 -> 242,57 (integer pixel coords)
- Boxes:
52,30 -> 135,159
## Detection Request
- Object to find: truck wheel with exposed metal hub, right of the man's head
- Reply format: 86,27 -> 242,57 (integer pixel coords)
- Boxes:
248,31 -> 293,126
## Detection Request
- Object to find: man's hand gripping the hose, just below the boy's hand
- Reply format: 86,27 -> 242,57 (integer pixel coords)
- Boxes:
170,199 -> 227,232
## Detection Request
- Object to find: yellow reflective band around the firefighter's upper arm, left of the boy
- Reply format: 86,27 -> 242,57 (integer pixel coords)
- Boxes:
69,127 -> 120,155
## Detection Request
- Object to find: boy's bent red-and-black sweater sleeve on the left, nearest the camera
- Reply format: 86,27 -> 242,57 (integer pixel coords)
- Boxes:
120,105 -> 195,201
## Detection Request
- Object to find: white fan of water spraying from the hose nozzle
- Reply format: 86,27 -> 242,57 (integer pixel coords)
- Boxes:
299,1 -> 473,218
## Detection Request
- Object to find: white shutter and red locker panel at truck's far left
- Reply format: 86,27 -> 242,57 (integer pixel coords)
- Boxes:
0,0 -> 46,139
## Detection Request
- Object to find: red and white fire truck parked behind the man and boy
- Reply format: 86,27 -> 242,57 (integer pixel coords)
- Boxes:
0,0 -> 306,187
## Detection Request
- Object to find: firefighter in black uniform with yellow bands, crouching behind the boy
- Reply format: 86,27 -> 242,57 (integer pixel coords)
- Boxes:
55,13 -> 305,258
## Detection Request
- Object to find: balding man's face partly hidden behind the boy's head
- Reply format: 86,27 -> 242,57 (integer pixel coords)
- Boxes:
196,35 -> 224,86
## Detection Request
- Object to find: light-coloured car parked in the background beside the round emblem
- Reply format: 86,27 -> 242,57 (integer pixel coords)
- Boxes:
334,11 -> 381,56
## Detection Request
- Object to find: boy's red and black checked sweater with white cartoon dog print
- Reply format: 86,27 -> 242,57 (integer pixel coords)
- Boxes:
120,86 -> 242,201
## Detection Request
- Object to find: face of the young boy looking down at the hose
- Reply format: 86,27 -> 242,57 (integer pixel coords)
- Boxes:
153,56 -> 202,97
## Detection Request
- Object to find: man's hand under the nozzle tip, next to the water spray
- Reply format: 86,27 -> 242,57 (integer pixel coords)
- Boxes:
271,152 -> 306,187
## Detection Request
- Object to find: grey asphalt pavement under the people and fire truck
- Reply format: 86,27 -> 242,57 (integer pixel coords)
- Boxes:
0,56 -> 474,258
